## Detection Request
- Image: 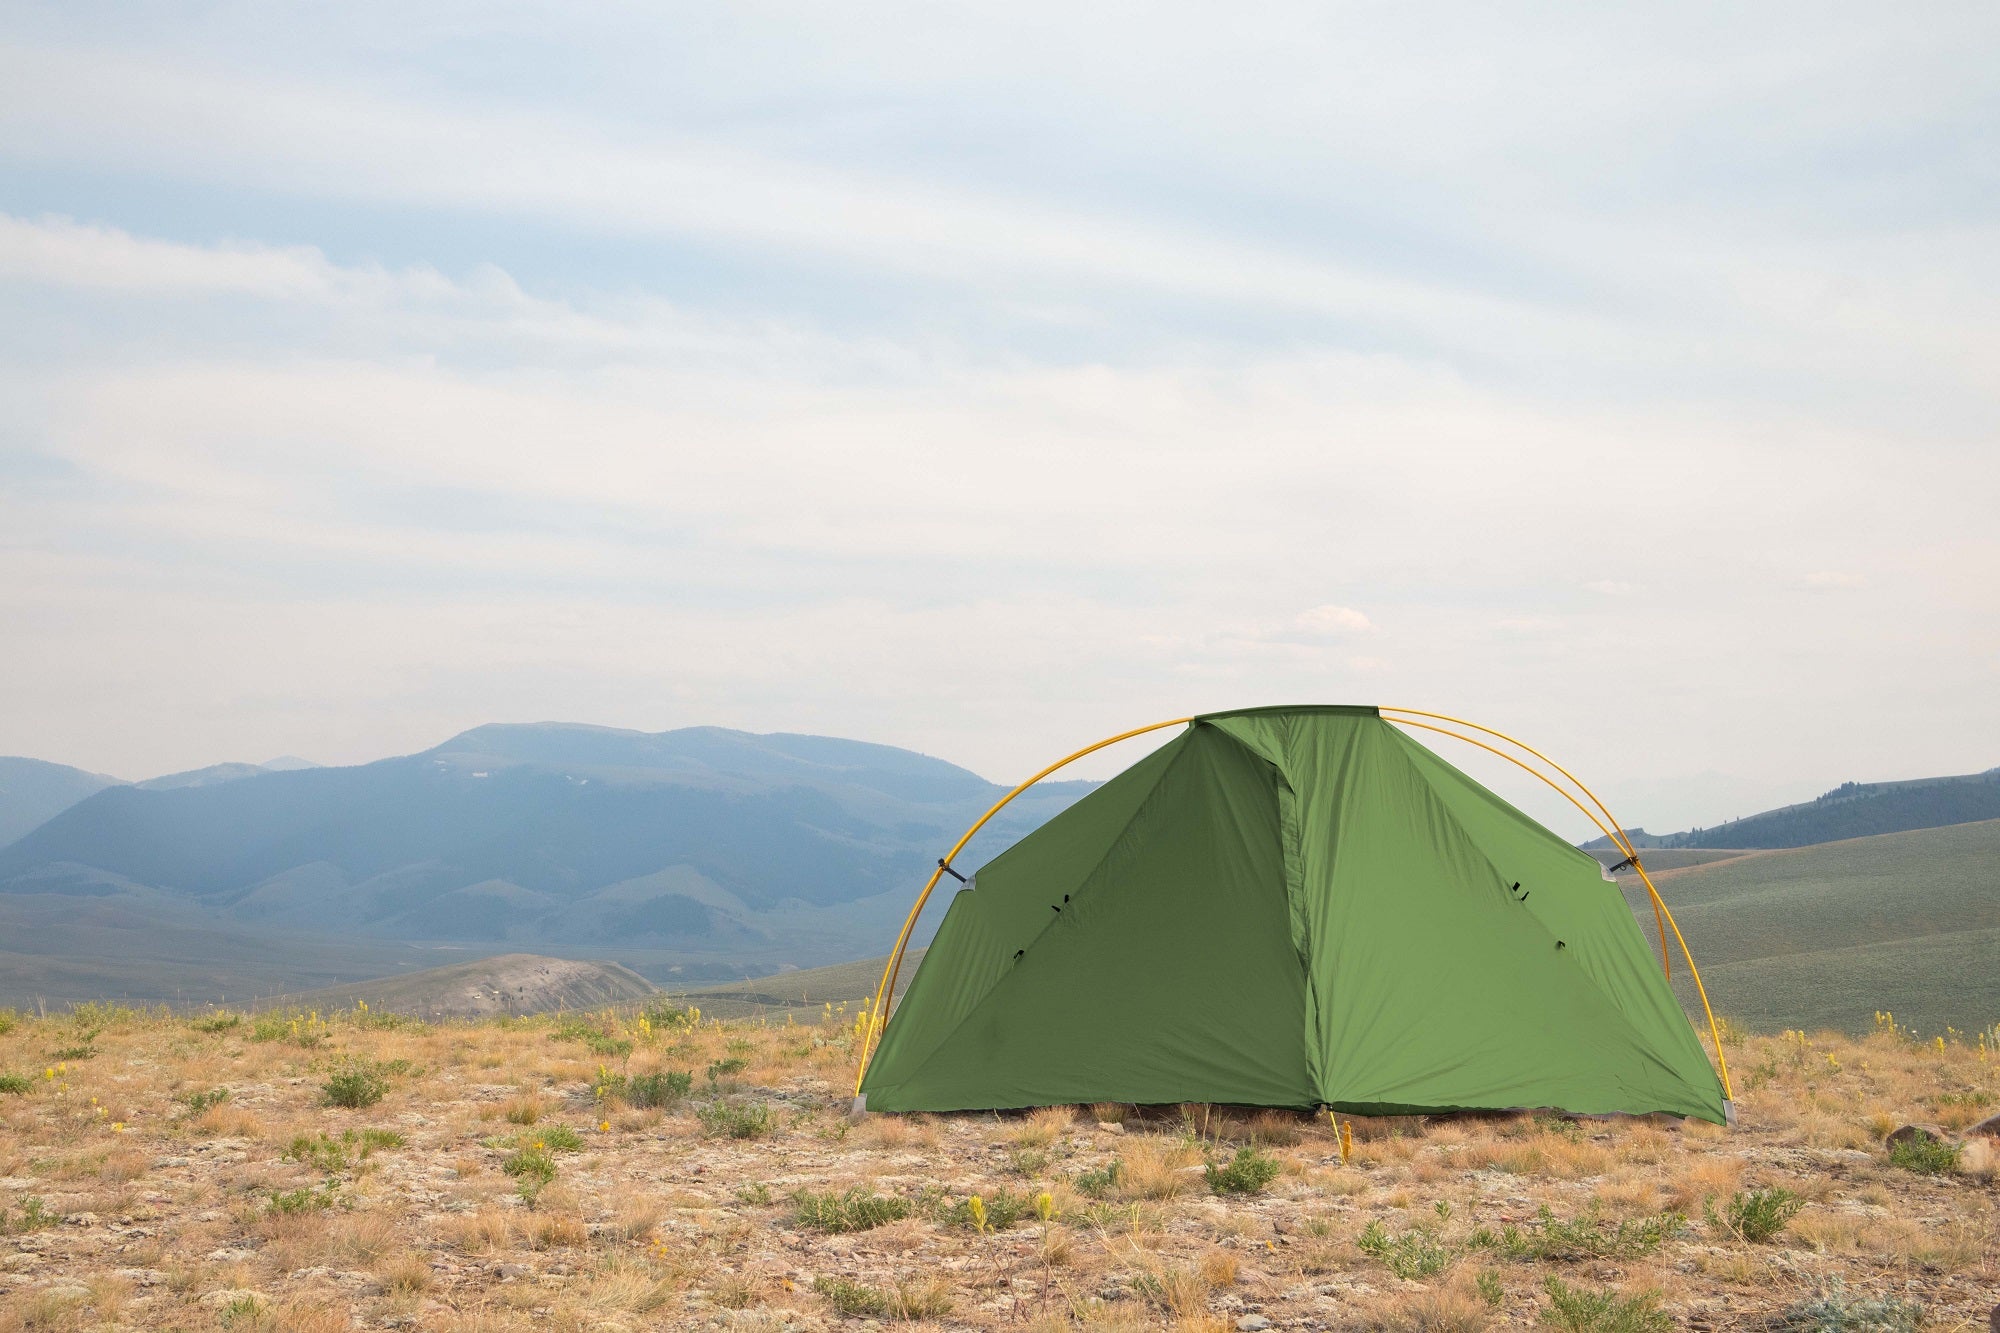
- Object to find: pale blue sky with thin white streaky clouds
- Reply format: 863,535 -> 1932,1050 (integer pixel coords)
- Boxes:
0,0 -> 2000,837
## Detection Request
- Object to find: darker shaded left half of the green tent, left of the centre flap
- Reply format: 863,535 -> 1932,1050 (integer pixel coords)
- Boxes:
862,727 -> 1316,1111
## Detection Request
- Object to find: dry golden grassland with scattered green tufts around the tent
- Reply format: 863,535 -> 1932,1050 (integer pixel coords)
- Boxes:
0,1003 -> 2000,1333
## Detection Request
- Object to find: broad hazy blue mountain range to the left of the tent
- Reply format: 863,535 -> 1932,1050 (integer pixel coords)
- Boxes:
0,723 -> 1092,963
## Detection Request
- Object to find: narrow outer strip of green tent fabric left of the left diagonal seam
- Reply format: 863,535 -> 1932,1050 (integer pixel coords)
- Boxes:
862,733 -> 1186,1091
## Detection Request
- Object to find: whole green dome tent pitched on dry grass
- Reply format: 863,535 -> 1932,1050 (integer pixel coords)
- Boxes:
856,707 -> 1730,1123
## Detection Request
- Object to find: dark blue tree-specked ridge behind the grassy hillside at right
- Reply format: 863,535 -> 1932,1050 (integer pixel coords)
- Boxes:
1582,769 -> 2000,851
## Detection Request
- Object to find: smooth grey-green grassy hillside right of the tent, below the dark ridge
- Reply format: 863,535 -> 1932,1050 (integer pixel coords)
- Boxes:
1620,821 -> 2000,1033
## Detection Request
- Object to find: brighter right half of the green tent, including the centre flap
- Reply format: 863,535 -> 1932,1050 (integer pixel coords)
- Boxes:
1204,711 -> 1722,1121
